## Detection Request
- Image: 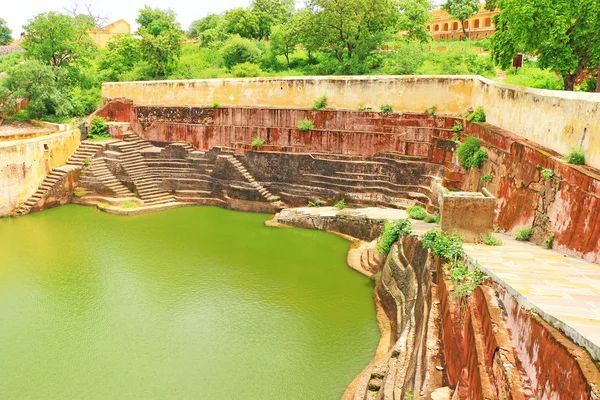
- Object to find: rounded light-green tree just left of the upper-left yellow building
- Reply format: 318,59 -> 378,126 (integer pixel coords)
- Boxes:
22,12 -> 95,67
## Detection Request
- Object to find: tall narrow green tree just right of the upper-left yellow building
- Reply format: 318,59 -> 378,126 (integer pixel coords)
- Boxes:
136,6 -> 184,78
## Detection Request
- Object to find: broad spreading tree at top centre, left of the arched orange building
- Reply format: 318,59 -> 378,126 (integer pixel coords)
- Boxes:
307,0 -> 400,63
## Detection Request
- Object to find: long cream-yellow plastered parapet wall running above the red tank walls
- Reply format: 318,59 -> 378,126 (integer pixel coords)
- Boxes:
102,76 -> 600,168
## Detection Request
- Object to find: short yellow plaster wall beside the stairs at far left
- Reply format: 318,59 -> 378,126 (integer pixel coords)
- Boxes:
0,129 -> 81,216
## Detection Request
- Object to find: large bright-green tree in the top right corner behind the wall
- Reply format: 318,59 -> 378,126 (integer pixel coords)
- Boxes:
491,0 -> 600,90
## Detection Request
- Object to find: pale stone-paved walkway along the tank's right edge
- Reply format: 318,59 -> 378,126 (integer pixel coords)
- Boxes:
276,207 -> 600,361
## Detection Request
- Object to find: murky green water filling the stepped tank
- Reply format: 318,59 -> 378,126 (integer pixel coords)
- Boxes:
0,206 -> 378,400
